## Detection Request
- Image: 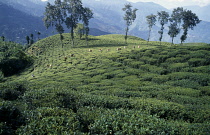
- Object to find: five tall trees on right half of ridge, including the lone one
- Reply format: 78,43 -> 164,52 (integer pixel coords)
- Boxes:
122,3 -> 201,44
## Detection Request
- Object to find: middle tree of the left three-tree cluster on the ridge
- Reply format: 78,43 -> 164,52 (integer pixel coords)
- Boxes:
64,0 -> 83,46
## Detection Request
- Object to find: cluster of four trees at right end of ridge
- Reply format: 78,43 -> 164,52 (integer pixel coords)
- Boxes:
146,7 -> 201,44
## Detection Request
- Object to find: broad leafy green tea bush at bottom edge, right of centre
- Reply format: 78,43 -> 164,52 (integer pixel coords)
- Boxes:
90,109 -> 205,135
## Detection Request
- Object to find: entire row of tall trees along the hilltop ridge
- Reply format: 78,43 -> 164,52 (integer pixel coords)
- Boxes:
43,0 -> 201,47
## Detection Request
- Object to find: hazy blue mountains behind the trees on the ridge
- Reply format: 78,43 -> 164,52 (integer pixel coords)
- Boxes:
0,0 -> 210,43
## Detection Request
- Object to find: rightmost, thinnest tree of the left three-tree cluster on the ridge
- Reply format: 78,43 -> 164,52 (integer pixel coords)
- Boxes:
82,7 -> 93,45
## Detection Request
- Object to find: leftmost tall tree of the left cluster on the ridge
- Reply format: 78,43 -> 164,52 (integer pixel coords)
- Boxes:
44,0 -> 66,47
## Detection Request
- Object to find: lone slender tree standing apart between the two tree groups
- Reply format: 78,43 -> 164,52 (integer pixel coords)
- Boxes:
122,3 -> 138,44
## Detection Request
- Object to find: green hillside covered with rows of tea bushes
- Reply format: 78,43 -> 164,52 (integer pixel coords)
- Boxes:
0,34 -> 210,135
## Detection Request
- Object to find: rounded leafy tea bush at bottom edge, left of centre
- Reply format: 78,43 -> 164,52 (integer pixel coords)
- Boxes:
18,108 -> 79,135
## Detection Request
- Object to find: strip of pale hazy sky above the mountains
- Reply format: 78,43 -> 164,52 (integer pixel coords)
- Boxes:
128,0 -> 210,8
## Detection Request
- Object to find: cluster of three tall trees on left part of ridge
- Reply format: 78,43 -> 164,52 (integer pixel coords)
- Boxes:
43,0 -> 93,47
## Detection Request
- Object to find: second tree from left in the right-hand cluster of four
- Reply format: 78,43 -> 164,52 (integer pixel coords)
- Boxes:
158,11 -> 169,44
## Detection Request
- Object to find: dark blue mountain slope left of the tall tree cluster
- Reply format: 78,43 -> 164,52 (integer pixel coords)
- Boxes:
0,2 -> 49,43
